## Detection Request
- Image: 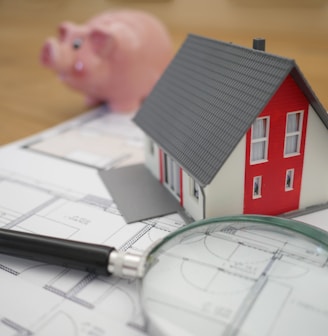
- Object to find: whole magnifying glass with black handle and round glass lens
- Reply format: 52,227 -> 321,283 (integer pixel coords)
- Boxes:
0,215 -> 328,336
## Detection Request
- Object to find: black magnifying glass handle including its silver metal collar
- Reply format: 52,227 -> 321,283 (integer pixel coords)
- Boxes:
0,229 -> 140,277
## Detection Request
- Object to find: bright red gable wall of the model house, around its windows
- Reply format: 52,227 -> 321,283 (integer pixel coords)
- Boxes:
244,75 -> 309,215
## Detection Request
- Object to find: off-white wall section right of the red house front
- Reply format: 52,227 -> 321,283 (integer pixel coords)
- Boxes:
300,107 -> 328,208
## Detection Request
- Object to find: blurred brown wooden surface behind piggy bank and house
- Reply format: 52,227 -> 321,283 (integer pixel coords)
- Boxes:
0,0 -> 328,145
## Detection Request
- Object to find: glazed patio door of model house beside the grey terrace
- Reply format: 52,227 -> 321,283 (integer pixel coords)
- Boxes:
162,153 -> 182,202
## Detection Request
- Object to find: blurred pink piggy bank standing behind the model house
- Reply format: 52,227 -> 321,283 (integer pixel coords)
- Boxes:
41,10 -> 173,112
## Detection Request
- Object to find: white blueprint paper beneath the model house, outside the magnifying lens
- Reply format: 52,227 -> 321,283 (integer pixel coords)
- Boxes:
0,107 -> 328,336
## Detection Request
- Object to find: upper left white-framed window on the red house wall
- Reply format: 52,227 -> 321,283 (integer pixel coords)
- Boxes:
251,117 -> 269,163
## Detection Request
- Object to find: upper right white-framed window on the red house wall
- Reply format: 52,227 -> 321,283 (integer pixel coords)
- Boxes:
285,111 -> 303,156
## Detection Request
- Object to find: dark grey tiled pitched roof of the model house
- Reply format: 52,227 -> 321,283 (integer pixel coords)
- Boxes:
134,35 -> 328,186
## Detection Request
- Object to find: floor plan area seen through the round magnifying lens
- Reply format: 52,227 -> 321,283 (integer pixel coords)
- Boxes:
143,222 -> 328,336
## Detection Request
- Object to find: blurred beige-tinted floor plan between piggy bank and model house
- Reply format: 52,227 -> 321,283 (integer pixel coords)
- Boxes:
25,108 -> 144,168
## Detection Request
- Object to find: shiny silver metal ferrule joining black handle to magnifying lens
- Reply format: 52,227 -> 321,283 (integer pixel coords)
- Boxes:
107,251 -> 143,278
